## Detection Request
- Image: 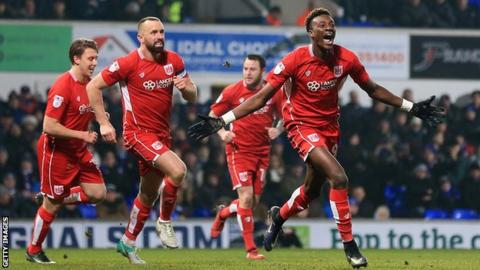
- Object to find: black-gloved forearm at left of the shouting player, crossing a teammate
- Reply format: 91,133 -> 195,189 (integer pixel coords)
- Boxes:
188,83 -> 278,140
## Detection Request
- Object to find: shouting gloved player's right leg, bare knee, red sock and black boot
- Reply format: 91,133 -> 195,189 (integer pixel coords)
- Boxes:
309,147 -> 367,268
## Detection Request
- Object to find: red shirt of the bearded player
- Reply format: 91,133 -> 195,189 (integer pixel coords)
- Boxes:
102,50 -> 188,137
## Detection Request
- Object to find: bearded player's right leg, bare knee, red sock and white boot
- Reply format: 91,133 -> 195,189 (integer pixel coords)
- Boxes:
154,150 -> 187,248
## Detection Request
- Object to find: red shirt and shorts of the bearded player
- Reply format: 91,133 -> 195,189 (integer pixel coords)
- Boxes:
102,50 -> 188,176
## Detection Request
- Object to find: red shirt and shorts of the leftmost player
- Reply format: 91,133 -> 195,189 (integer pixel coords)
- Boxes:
37,72 -> 103,199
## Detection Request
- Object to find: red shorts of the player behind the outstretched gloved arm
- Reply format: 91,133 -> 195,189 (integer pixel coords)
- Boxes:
227,151 -> 270,195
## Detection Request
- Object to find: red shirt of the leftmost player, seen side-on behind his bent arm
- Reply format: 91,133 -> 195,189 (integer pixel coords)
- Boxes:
42,72 -> 95,153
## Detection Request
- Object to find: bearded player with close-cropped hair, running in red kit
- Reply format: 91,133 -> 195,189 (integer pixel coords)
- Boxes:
87,17 -> 197,264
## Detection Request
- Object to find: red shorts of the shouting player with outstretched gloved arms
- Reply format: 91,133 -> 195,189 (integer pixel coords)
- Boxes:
287,122 -> 340,161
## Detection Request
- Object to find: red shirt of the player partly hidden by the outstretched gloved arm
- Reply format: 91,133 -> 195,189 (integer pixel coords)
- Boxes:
211,80 -> 282,153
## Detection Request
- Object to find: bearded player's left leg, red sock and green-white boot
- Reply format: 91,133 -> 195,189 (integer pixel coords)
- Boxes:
117,169 -> 162,264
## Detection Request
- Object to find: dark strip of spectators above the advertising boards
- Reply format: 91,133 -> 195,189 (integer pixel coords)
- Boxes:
0,0 -> 480,28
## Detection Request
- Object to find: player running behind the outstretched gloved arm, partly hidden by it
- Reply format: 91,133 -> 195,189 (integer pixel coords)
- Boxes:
209,54 -> 283,260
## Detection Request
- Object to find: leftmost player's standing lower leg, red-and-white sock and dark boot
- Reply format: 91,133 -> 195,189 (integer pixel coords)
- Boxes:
25,197 -> 62,264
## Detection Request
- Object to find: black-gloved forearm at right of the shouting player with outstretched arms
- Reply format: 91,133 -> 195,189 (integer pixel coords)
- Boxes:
360,80 -> 446,126
